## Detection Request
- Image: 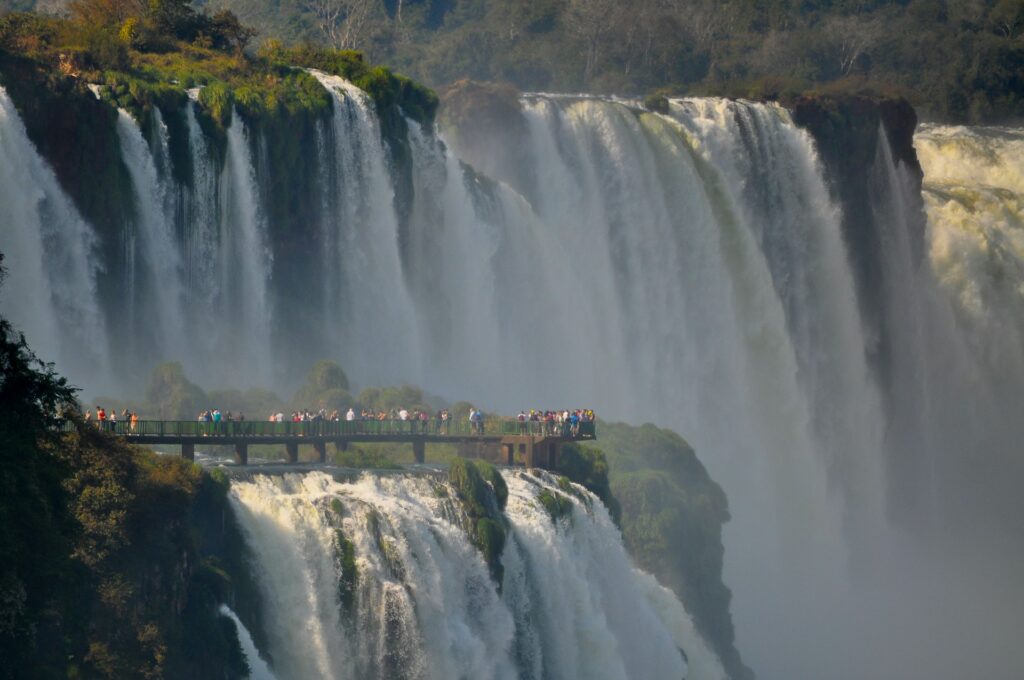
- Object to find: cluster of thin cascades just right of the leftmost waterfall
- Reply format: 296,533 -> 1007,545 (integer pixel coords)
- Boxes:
109,102 -> 271,384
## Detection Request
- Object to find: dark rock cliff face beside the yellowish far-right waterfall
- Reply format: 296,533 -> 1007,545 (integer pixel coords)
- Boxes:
782,95 -> 926,383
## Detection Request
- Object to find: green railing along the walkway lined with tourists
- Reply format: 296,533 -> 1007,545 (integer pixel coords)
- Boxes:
63,418 -> 597,439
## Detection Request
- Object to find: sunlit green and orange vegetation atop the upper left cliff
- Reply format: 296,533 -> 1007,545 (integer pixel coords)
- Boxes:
0,0 -> 437,127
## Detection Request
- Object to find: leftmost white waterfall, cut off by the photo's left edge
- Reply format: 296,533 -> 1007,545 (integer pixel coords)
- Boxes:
0,87 -> 110,386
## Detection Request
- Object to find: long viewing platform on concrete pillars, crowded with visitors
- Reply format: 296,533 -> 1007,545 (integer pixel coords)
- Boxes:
65,418 -> 597,470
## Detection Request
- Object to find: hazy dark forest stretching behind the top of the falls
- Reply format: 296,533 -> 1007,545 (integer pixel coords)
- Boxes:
0,0 -> 1024,123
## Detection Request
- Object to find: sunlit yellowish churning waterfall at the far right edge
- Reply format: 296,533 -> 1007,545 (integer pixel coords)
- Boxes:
914,126 -> 1024,398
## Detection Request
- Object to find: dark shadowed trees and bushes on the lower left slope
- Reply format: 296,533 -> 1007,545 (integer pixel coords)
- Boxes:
0,251 -> 249,678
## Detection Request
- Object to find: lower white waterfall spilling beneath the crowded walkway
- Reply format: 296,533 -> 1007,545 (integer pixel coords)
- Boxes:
230,472 -> 724,680
